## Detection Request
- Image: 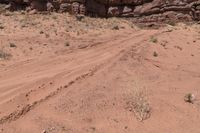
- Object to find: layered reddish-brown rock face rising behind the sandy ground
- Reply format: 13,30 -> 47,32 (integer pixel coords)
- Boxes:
2,0 -> 200,21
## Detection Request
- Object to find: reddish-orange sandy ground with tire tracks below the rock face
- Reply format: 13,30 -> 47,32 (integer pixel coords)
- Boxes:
0,14 -> 200,133
